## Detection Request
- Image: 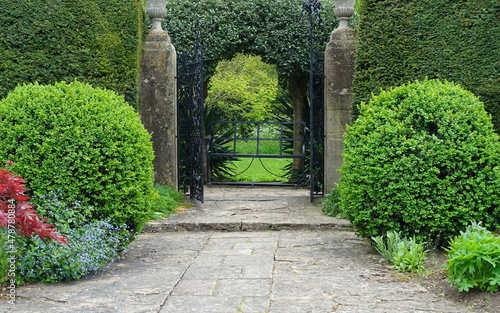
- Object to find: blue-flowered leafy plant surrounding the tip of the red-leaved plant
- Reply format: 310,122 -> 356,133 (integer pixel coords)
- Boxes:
15,190 -> 134,283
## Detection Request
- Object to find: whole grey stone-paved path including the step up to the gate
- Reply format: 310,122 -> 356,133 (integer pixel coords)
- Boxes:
0,188 -> 467,313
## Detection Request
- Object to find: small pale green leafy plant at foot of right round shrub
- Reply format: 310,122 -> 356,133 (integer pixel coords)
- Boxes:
372,231 -> 427,273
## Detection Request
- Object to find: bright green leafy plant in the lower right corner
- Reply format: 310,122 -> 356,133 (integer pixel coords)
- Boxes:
446,223 -> 500,292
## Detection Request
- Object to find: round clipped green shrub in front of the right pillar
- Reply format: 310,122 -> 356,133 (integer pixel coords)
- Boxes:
339,80 -> 500,246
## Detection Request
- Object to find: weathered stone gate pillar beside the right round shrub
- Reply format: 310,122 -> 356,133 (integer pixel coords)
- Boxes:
324,6 -> 356,192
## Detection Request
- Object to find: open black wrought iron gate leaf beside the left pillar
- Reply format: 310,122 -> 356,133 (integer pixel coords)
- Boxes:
177,36 -> 205,202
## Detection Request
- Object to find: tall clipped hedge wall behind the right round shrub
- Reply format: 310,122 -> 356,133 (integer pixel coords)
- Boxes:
354,0 -> 500,132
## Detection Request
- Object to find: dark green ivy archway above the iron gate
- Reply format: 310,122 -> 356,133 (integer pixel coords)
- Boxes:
163,0 -> 337,176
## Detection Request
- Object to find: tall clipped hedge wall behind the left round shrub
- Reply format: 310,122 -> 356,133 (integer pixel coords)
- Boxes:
0,0 -> 144,106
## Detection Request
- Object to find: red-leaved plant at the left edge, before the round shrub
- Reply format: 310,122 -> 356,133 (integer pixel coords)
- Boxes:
0,161 -> 68,243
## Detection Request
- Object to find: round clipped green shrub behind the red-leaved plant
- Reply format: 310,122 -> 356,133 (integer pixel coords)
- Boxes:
0,82 -> 156,231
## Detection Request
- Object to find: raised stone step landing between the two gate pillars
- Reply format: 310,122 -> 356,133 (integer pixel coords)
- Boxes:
143,186 -> 352,233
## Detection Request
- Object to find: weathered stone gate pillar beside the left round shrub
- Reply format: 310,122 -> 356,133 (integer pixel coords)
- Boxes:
140,0 -> 178,189
